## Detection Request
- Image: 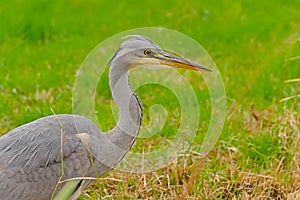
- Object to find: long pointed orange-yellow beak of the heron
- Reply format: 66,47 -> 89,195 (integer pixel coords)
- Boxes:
155,52 -> 211,72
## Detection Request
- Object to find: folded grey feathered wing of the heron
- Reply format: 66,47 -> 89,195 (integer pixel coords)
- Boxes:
0,115 -> 99,199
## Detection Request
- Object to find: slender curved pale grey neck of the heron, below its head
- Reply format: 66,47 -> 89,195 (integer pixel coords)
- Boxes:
107,63 -> 142,151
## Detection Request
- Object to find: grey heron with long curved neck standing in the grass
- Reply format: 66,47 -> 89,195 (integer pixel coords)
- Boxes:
0,35 -> 210,200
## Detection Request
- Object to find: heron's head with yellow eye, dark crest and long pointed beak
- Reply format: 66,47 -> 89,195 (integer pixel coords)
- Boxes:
110,35 -> 211,71
